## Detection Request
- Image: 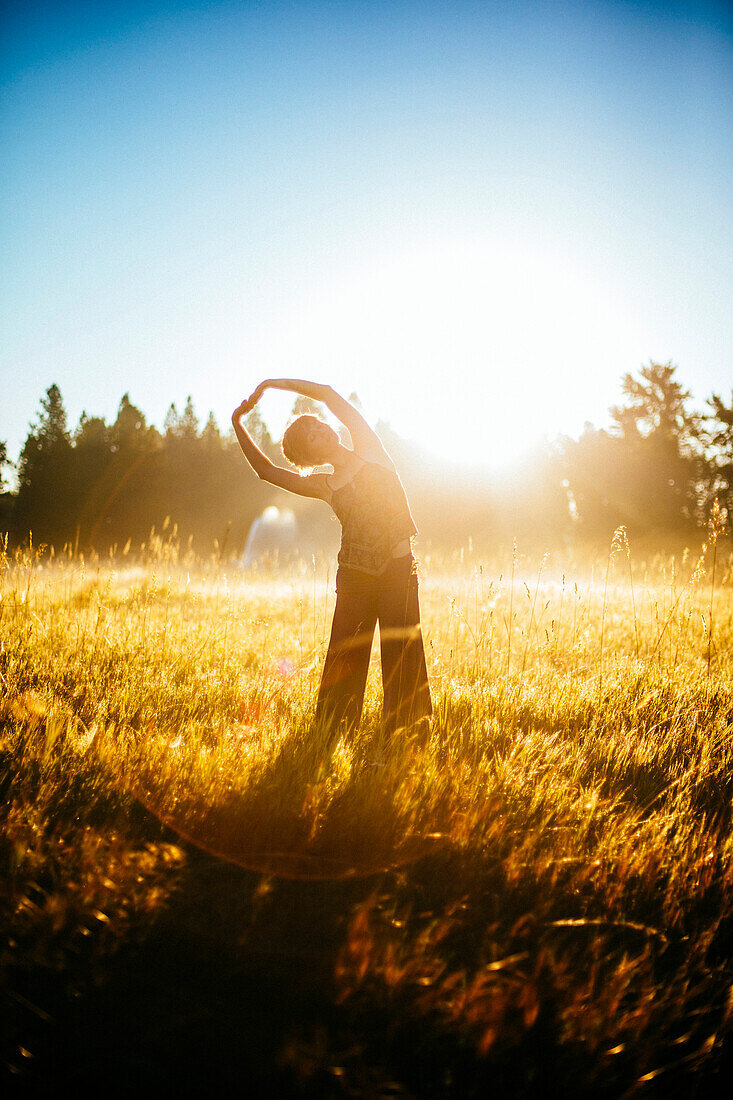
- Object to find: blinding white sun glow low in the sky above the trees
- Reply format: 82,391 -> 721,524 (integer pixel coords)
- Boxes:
242,241 -> 637,468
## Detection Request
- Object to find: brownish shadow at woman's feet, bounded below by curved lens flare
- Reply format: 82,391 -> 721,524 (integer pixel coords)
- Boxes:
132,729 -> 444,881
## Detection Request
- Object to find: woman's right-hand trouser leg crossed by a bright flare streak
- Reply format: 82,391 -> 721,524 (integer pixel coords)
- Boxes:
378,560 -> 433,733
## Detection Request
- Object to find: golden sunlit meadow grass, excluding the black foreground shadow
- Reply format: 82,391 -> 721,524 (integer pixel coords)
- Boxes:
0,531 -> 733,1095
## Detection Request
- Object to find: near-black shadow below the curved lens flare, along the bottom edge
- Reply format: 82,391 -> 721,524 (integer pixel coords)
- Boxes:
17,836 -> 725,1100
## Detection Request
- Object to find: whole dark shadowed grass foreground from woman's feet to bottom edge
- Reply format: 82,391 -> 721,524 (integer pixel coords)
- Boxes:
5,699 -> 731,1100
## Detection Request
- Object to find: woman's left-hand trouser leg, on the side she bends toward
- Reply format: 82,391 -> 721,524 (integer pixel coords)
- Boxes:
316,582 -> 376,730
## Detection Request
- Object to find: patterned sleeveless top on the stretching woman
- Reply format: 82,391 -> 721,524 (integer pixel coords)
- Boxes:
331,462 -> 417,576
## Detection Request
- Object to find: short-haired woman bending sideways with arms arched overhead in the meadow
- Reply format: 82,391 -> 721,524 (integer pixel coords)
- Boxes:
232,378 -> 433,732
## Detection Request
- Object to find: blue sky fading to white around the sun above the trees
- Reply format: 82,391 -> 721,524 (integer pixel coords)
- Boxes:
0,0 -> 733,475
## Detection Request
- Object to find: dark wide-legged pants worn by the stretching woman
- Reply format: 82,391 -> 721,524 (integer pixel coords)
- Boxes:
316,554 -> 433,732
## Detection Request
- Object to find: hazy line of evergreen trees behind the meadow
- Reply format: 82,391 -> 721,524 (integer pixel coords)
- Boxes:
0,362 -> 733,553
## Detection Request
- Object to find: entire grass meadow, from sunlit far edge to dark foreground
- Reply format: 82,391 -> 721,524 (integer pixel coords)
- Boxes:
0,531 -> 733,1097
